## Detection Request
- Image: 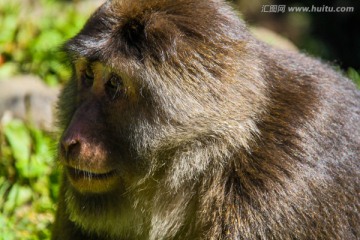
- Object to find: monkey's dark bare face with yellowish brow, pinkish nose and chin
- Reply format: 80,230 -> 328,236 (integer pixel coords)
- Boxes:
60,58 -> 141,193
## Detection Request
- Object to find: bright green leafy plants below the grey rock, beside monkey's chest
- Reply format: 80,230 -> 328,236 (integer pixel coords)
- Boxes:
0,120 -> 59,240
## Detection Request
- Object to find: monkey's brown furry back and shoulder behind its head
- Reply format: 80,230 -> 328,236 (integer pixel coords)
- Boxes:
219,43 -> 360,239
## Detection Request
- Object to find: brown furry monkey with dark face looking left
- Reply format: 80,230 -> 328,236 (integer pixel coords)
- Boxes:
52,0 -> 360,240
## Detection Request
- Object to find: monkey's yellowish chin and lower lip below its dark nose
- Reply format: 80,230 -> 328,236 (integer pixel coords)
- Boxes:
67,167 -> 119,194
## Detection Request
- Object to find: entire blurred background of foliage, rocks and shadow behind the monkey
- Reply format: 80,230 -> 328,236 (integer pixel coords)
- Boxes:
0,0 -> 360,240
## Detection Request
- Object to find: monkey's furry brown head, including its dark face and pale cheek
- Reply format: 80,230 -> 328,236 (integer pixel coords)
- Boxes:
59,0 -> 265,232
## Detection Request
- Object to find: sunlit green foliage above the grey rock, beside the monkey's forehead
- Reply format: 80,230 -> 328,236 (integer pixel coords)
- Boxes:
0,0 -> 88,85
